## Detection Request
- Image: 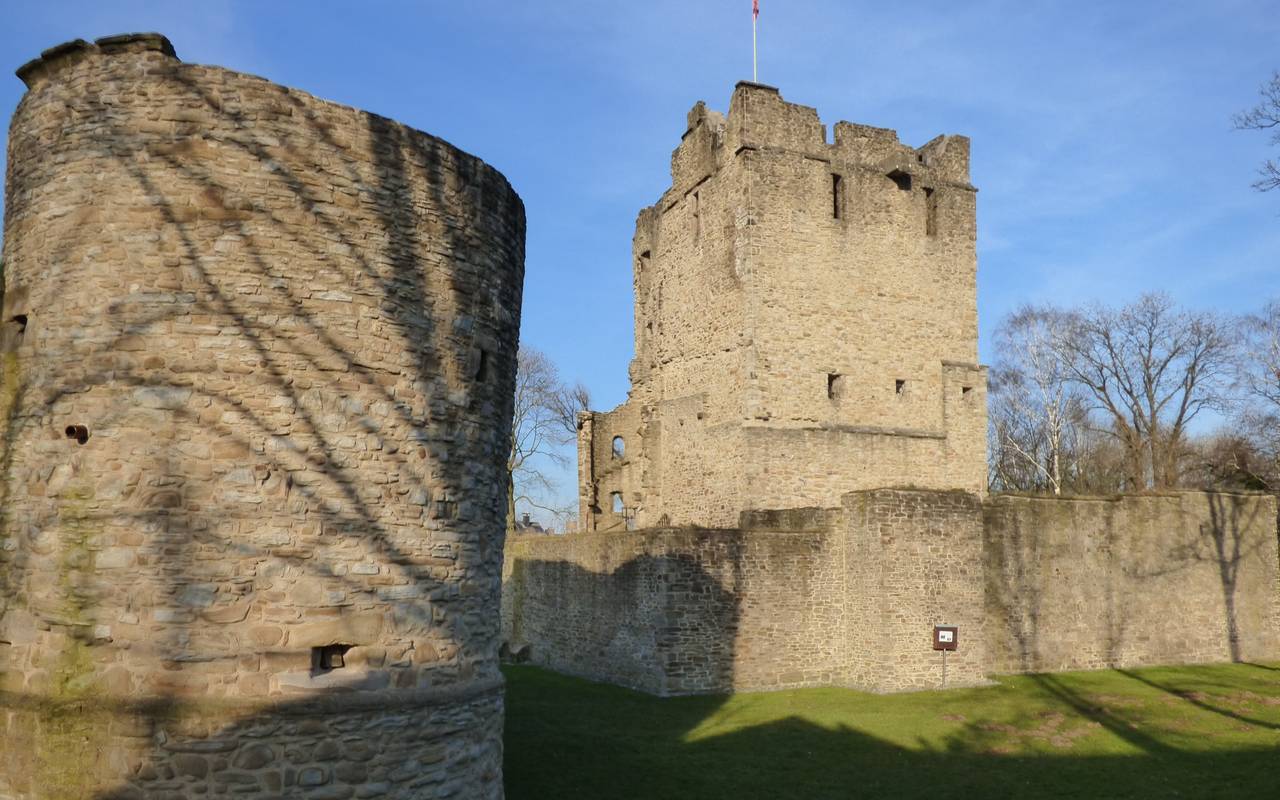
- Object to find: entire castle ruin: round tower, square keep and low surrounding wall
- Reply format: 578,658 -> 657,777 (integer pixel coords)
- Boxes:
0,26 -> 1280,800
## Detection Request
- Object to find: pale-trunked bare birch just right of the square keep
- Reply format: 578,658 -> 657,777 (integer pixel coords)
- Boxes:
991,306 -> 1084,494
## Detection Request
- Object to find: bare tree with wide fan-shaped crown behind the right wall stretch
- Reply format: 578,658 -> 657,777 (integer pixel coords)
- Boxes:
1060,293 -> 1233,490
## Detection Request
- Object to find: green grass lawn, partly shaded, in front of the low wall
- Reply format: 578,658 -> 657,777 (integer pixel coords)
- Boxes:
506,664 -> 1280,800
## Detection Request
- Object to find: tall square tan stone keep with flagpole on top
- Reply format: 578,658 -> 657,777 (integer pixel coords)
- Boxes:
579,83 -> 987,530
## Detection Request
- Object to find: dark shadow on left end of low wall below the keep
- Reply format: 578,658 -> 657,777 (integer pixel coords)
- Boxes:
507,547 -> 742,695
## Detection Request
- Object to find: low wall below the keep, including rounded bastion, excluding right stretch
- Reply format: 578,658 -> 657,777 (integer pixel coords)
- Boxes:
503,489 -> 984,695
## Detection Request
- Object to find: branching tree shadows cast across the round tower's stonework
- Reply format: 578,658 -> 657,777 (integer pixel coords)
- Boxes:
0,45 -> 522,800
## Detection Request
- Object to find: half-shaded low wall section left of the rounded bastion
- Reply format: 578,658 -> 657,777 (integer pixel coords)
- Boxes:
503,515 -> 840,695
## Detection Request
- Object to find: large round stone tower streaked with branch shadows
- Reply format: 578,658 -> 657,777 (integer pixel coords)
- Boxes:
0,35 -> 525,800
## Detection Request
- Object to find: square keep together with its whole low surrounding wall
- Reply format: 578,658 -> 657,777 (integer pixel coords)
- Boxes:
503,83 -> 1280,695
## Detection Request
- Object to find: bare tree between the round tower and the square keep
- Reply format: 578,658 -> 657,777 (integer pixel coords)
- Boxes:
507,346 -> 591,534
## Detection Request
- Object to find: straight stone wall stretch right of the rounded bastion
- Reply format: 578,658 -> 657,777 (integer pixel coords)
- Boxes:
984,492 -> 1280,672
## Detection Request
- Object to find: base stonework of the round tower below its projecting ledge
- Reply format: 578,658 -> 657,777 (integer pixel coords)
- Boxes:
0,682 -> 503,800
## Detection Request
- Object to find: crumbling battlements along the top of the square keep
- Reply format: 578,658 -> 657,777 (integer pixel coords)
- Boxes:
671,81 -> 973,196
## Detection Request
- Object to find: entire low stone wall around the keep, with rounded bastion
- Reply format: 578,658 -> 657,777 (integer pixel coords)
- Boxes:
503,489 -> 1280,694
